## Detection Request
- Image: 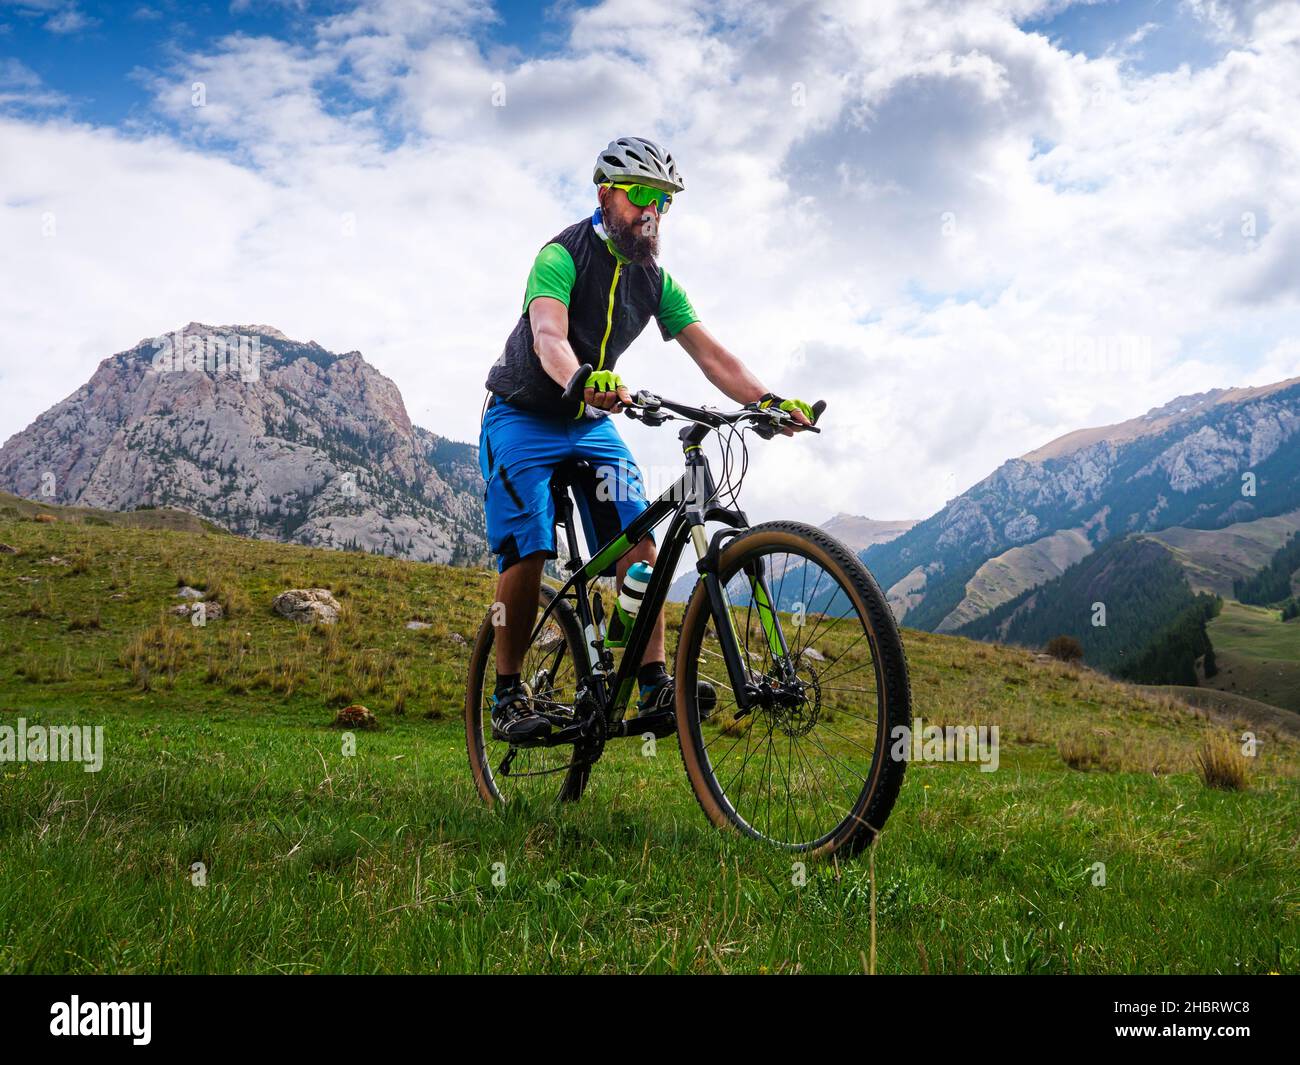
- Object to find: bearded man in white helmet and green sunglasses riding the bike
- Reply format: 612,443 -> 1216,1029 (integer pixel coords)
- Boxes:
478,137 -> 813,740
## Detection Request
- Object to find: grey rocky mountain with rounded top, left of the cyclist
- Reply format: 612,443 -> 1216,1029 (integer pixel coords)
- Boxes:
0,322 -> 486,563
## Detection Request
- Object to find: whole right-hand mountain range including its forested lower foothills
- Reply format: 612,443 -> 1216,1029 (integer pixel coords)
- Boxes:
862,378 -> 1300,709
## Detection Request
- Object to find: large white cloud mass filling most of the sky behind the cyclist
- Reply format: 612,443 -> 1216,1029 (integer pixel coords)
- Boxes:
0,0 -> 1300,520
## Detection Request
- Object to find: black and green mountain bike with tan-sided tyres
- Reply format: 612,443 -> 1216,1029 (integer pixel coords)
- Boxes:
465,367 -> 911,856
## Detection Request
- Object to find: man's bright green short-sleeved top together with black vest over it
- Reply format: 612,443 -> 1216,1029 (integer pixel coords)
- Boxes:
488,211 -> 699,417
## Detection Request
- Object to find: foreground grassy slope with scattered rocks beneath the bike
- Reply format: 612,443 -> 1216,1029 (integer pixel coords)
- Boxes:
0,514 -> 1300,973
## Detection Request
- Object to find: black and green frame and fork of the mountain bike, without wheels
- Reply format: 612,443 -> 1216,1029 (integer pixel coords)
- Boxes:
532,424 -> 788,743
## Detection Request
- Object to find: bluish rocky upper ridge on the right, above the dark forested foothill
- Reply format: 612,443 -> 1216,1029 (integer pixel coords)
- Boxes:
863,378 -> 1300,631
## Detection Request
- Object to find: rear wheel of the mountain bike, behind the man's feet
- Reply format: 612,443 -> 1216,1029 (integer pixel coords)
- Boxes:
465,584 -> 592,806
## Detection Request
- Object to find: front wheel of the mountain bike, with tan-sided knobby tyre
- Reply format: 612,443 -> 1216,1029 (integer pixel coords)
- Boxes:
675,521 -> 911,856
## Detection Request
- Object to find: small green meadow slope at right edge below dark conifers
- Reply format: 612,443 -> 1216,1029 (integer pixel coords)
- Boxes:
1204,599 -> 1300,711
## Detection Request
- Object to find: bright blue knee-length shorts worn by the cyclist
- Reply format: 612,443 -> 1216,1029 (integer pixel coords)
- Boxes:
478,399 -> 647,576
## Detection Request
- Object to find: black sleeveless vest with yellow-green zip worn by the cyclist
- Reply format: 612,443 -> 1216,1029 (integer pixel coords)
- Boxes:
488,218 -> 668,417
